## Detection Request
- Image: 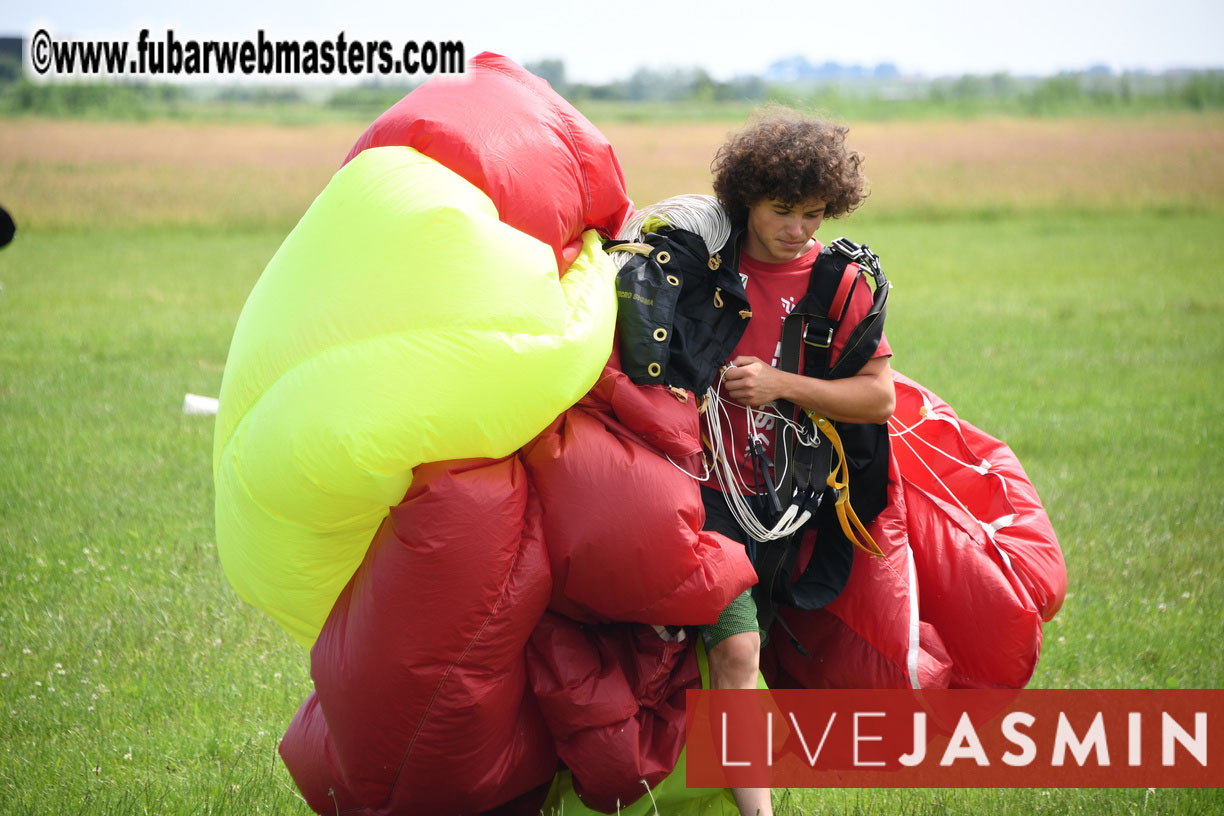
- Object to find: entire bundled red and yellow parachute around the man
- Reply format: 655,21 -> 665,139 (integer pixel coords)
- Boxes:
214,54 -> 1065,814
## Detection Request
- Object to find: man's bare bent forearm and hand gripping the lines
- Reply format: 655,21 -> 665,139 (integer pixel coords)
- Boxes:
723,357 -> 897,425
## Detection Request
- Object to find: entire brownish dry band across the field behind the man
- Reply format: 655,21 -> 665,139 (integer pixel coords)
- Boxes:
0,114 -> 1224,228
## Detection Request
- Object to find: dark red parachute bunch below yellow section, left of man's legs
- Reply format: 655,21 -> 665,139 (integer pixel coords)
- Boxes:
282,367 -> 755,814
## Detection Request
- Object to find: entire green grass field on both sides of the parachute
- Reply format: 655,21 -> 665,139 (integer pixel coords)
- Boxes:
0,111 -> 1224,816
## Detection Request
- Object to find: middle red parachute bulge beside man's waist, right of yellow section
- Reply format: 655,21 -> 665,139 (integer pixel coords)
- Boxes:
523,358 -> 755,625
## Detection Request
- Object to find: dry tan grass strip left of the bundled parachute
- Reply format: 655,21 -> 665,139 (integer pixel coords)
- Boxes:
0,120 -> 362,229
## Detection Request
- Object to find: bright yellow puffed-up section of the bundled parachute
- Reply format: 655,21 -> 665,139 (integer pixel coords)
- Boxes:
213,147 -> 616,646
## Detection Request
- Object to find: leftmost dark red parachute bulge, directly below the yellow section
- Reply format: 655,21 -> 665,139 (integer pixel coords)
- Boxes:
282,458 -> 556,814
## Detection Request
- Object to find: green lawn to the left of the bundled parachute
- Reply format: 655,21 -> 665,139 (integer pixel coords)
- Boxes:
0,230 -> 310,814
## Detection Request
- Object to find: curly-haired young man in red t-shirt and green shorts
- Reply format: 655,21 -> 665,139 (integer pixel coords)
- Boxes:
703,114 -> 896,816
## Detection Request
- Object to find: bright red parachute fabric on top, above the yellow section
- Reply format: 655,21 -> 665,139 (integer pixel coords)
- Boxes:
345,51 -> 632,272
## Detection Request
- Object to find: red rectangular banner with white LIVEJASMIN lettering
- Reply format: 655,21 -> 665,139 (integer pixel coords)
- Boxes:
688,690 -> 1224,788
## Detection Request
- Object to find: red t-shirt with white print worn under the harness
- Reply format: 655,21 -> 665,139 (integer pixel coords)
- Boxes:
705,241 -> 892,489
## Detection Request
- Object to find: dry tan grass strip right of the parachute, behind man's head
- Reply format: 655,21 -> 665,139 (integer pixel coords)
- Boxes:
603,115 -> 1224,215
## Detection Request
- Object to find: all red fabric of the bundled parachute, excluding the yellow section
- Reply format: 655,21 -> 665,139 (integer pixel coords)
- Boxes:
280,54 -> 1066,815
